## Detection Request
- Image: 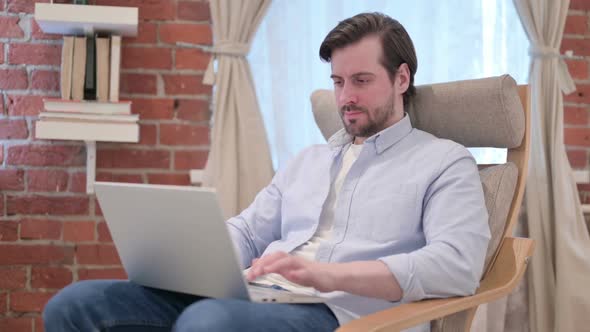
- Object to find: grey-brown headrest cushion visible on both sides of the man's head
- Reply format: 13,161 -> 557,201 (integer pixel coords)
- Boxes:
311,75 -> 524,148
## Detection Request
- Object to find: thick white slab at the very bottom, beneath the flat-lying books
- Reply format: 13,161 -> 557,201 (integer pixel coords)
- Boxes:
35,120 -> 139,143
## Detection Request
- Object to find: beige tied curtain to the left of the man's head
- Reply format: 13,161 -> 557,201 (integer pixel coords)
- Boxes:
203,0 -> 273,218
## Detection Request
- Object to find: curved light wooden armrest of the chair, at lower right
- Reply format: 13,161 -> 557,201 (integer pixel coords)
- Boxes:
337,237 -> 534,332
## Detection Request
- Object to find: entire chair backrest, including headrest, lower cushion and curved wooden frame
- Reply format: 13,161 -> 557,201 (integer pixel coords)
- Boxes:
311,75 -> 530,331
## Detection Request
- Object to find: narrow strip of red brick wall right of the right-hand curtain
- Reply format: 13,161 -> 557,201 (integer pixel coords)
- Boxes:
562,0 -> 590,211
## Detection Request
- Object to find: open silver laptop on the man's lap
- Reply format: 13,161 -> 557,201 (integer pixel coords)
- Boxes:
94,182 -> 325,303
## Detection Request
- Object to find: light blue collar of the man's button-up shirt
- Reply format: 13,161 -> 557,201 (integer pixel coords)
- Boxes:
328,113 -> 413,154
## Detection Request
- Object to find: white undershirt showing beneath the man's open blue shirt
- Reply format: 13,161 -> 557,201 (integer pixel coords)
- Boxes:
247,144 -> 363,295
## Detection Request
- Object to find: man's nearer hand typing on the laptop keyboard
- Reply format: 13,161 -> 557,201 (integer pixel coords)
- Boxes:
247,252 -> 336,292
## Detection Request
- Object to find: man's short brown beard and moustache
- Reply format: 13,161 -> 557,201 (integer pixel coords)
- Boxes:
340,94 -> 395,138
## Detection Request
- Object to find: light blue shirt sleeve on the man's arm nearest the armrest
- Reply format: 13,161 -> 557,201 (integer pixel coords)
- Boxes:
380,145 -> 490,302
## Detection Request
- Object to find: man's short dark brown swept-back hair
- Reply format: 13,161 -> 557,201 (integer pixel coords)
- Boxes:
320,13 -> 418,105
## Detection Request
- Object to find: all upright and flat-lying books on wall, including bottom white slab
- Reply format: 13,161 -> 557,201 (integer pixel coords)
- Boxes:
36,35 -> 139,142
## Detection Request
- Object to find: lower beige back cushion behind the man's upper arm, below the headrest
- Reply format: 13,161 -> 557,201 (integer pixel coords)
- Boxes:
479,162 -> 518,271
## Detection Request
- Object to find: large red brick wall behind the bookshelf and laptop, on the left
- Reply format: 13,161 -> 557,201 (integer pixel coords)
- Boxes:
0,0 -> 212,332
